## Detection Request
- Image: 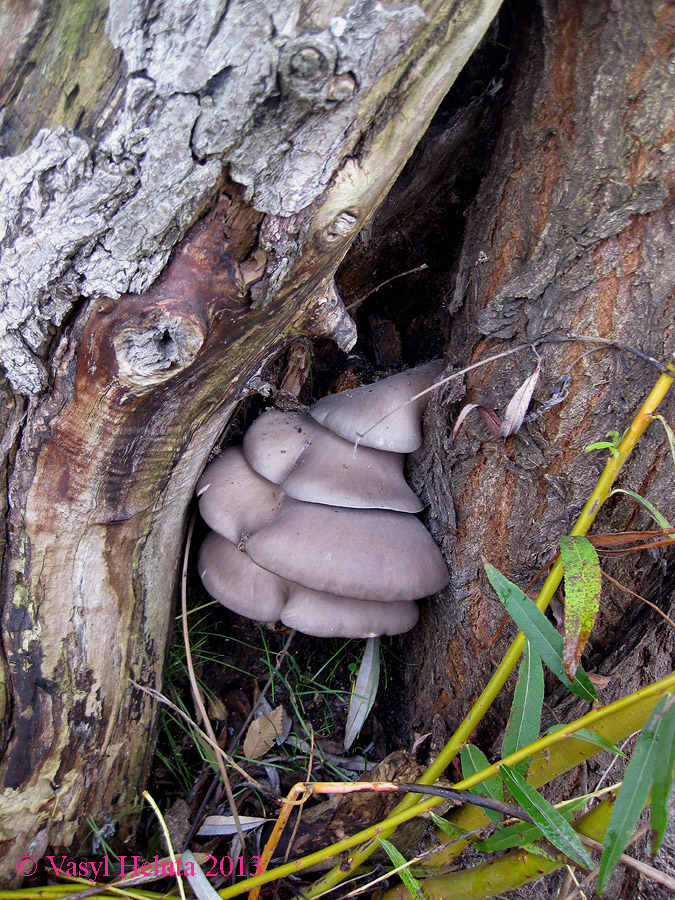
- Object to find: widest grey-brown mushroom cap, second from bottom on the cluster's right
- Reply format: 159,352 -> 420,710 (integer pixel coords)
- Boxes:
245,499 -> 450,602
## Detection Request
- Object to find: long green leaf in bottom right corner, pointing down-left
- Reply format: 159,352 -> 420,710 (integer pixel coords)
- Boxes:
598,697 -> 668,894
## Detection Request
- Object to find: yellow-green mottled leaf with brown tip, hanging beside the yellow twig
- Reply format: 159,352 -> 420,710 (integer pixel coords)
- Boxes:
560,537 -> 602,679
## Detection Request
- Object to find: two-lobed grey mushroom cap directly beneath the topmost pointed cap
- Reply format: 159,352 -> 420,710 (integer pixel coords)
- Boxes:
244,410 -> 423,513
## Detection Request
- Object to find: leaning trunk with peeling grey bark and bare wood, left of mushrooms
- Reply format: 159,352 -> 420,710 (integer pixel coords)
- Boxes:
0,0 -> 499,878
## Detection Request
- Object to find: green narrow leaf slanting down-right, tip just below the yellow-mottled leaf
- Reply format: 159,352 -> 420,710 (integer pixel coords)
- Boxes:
484,562 -> 598,702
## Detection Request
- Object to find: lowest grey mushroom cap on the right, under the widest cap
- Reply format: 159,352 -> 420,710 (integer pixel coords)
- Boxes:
281,582 -> 419,638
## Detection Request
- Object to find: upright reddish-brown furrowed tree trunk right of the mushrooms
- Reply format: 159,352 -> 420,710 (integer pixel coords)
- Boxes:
398,0 -> 675,744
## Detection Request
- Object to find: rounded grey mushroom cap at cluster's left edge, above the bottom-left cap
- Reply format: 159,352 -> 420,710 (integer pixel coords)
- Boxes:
197,447 -> 283,544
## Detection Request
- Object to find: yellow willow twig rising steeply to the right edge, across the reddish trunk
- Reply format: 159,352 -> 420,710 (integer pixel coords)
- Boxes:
305,355 -> 675,898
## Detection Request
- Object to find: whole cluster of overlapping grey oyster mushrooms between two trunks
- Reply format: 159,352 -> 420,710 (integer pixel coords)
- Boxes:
197,361 -> 449,638
